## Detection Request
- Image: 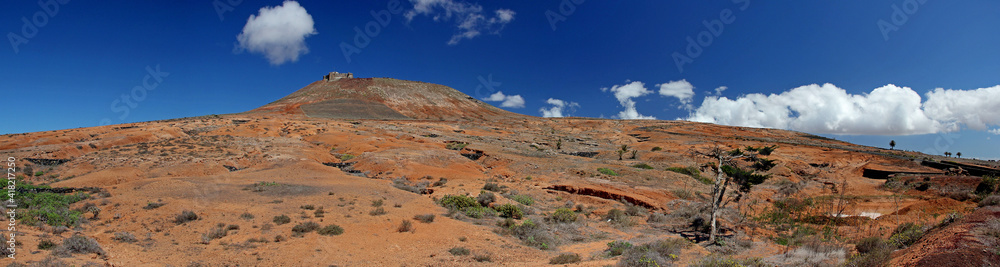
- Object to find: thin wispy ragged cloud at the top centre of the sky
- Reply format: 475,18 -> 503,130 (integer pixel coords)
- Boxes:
404,0 -> 517,45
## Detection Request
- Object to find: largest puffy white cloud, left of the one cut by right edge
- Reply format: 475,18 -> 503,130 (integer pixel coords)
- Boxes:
688,84 -> 945,135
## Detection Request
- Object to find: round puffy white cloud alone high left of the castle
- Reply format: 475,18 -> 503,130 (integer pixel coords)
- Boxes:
236,1 -> 316,65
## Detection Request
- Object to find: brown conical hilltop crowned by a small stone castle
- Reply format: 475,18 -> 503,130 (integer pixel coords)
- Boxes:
250,72 -> 523,120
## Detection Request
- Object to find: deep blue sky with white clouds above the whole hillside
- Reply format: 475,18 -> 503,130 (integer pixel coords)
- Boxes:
0,0 -> 1000,158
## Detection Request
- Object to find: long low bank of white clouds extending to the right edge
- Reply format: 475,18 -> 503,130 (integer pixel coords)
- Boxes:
687,84 -> 1000,135
